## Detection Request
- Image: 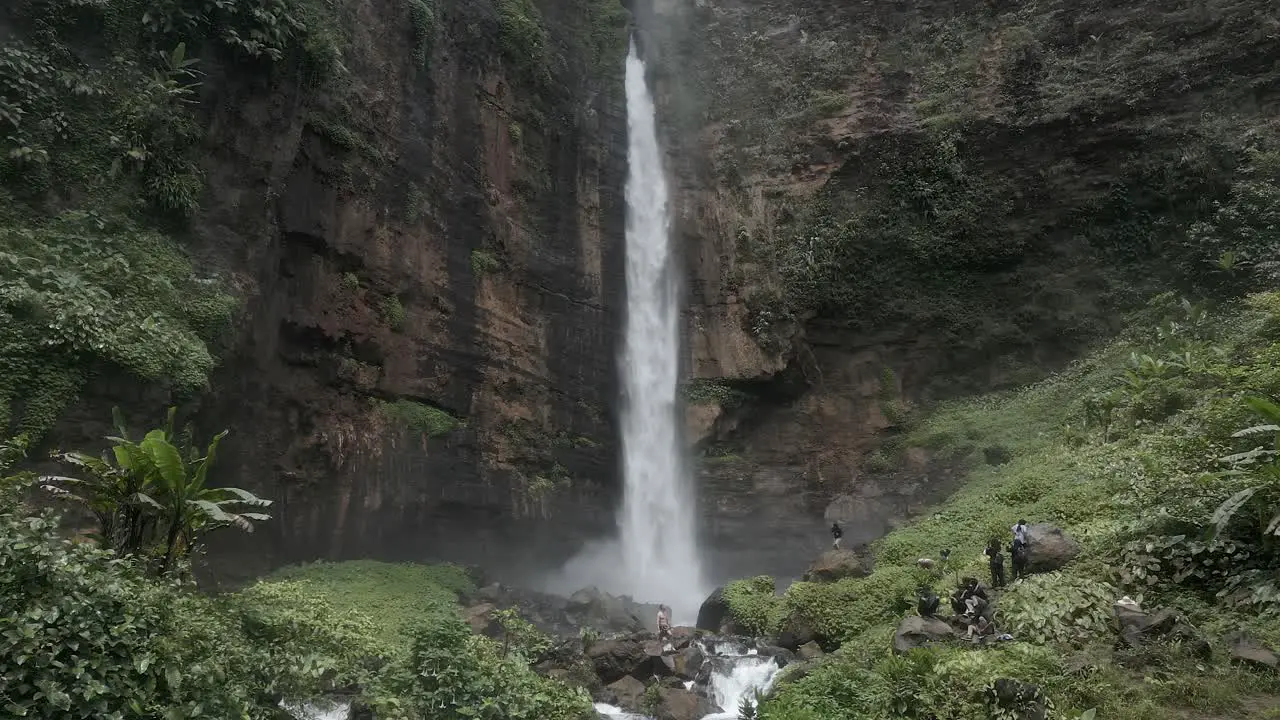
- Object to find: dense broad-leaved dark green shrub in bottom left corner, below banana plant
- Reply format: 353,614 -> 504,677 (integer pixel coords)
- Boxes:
0,512 -> 269,720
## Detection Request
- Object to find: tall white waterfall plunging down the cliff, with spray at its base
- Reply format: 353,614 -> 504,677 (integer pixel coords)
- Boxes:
535,42 -> 709,624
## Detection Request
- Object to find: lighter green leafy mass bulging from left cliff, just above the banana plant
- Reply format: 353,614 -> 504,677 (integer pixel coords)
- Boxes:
0,211 -> 236,437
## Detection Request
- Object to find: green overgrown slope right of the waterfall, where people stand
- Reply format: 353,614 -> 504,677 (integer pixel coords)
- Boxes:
727,293 -> 1280,720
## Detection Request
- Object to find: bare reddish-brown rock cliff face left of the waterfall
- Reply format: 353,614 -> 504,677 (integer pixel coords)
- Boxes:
49,0 -> 626,577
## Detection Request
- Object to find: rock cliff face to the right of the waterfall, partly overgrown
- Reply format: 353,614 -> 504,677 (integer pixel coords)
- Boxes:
641,0 -> 1280,575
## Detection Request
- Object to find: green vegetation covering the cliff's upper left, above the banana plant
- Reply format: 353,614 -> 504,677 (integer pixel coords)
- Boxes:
0,0 -> 342,436
